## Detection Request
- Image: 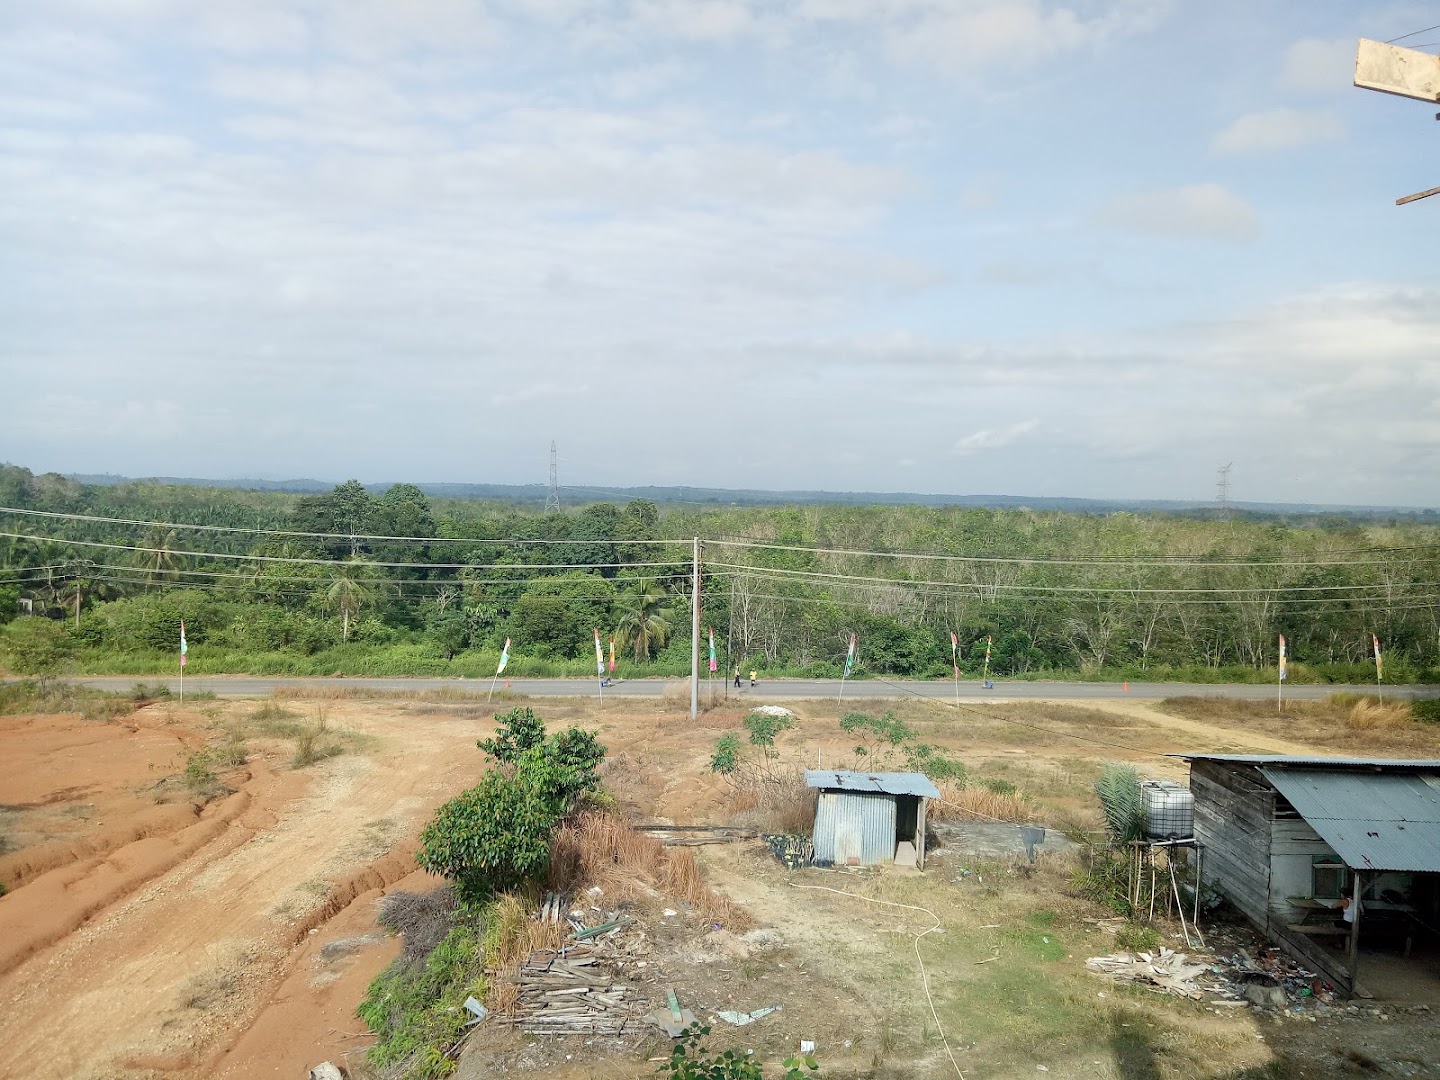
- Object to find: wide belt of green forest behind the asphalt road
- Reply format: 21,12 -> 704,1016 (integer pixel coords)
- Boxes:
0,465 -> 1440,683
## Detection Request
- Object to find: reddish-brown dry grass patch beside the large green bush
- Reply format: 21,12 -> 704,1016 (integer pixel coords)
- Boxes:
550,811 -> 746,926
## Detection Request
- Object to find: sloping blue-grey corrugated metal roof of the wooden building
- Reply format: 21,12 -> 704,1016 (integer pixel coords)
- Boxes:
1260,762 -> 1440,873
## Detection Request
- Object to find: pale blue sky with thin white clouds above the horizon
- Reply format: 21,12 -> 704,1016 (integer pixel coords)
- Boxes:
0,0 -> 1440,507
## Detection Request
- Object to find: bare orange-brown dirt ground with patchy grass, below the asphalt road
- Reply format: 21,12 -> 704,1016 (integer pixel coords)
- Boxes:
0,698 -> 1440,1080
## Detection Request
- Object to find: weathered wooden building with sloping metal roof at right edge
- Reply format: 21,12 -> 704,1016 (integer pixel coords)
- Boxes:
1175,755 -> 1440,992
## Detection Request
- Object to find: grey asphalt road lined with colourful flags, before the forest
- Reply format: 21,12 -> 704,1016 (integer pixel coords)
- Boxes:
59,675 -> 1440,701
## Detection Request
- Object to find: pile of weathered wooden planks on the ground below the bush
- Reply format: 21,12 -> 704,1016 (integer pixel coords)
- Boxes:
503,942 -> 645,1035
